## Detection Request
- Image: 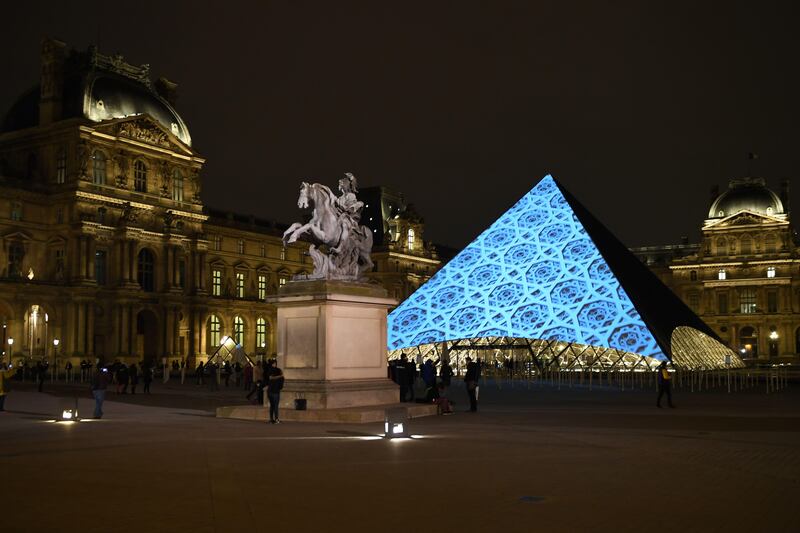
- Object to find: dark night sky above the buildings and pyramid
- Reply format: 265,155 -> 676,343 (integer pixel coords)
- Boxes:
0,0 -> 800,246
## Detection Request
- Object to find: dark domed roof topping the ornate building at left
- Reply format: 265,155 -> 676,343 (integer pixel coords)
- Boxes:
2,47 -> 192,146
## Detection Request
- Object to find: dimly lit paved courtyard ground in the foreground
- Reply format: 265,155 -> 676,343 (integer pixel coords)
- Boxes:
0,383 -> 800,533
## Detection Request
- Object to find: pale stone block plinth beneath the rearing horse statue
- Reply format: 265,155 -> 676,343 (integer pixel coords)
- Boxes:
270,280 -> 399,409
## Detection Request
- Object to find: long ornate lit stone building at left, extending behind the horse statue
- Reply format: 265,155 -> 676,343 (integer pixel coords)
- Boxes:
0,39 -> 440,365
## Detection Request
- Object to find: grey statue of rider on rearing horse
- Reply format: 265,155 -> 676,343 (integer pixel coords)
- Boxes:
283,172 -> 372,281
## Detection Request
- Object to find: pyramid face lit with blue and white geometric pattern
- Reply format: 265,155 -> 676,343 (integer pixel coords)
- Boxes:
389,176 -> 666,359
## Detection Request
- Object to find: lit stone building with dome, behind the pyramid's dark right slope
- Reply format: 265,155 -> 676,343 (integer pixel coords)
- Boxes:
633,177 -> 800,365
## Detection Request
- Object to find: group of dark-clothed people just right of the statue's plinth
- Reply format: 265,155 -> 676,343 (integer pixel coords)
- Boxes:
389,354 -> 480,414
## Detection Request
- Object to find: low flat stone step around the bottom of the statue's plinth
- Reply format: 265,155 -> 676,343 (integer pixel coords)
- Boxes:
217,403 -> 438,424
